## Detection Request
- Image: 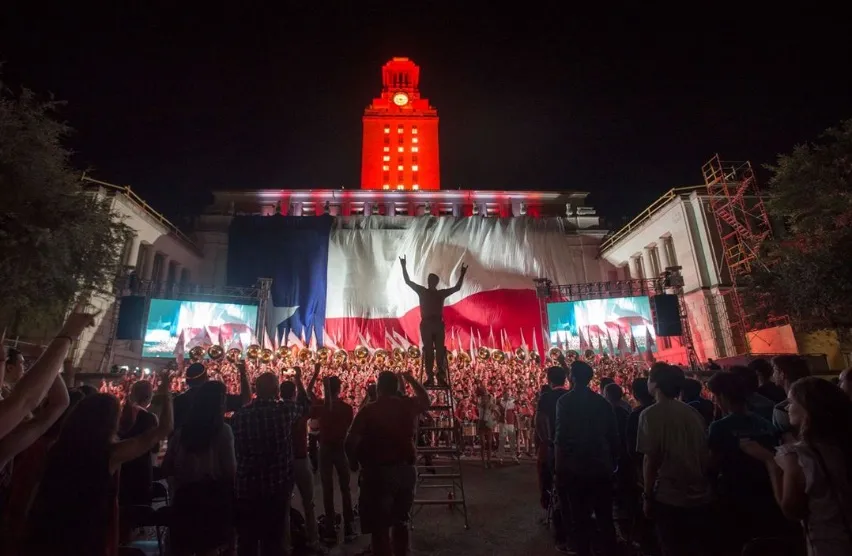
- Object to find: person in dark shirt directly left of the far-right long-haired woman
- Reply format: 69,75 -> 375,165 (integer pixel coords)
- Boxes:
707,372 -> 785,552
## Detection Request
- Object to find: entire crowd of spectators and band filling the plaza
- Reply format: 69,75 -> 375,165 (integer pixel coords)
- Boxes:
0,304 -> 852,556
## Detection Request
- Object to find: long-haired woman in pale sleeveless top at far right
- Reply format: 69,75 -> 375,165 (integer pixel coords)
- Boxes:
741,377 -> 852,556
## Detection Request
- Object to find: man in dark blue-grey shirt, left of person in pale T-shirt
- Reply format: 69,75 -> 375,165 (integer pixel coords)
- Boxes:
555,361 -> 619,556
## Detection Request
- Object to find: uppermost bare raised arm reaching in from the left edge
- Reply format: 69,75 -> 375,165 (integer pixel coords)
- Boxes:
0,307 -> 95,438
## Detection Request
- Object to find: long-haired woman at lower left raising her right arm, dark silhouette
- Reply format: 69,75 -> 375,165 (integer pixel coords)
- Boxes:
26,375 -> 172,556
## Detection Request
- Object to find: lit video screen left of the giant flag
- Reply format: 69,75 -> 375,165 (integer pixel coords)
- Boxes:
142,299 -> 257,357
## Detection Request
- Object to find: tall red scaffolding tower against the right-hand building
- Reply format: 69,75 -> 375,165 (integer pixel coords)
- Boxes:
701,154 -> 786,354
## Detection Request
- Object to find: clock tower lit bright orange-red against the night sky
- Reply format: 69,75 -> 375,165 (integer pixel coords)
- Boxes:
361,58 -> 441,191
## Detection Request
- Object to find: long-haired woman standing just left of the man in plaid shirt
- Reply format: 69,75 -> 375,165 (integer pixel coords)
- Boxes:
163,381 -> 237,555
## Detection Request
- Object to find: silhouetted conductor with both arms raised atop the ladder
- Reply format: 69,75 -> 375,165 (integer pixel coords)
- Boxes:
399,257 -> 467,386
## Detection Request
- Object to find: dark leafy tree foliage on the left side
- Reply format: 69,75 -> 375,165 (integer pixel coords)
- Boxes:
0,83 -> 130,328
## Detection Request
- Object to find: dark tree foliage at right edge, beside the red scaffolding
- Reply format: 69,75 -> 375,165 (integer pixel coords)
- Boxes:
745,120 -> 852,330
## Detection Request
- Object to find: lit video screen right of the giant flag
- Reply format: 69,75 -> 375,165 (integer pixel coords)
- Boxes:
547,296 -> 657,355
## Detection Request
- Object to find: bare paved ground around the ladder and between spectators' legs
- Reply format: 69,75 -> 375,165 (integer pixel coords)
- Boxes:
134,459 -> 558,556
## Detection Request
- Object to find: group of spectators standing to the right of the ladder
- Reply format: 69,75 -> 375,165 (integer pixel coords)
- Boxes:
536,355 -> 852,556
